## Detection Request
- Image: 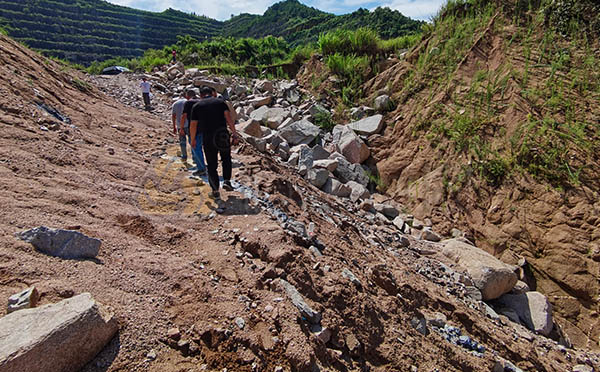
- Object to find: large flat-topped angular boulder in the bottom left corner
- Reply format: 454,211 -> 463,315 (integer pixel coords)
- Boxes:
0,293 -> 118,372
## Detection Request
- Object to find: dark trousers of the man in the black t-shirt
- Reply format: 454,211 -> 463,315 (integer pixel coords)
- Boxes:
203,129 -> 232,191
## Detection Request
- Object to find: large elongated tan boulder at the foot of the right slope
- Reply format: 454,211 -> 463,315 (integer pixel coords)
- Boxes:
441,239 -> 517,301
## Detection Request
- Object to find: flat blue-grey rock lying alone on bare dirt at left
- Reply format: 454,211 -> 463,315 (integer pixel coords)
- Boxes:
17,226 -> 102,259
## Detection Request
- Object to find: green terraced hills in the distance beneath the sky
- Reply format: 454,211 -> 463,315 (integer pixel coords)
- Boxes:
0,0 -> 422,64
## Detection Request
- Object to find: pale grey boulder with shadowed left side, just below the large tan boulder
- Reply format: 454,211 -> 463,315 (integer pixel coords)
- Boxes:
498,292 -> 554,336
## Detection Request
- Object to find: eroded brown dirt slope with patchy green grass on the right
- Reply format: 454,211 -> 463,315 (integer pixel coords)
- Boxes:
367,2 -> 600,349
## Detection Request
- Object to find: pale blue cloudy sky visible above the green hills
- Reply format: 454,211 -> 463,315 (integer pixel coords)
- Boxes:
108,0 -> 446,21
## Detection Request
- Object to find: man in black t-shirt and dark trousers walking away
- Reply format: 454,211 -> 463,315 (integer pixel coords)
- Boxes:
190,87 -> 238,199
